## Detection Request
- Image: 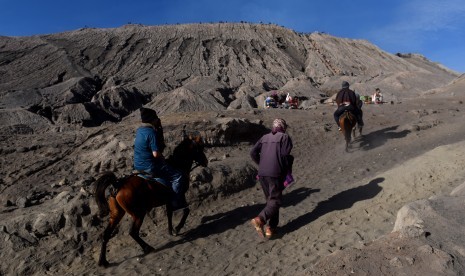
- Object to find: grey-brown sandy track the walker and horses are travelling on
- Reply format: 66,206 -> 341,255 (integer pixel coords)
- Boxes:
40,95 -> 465,275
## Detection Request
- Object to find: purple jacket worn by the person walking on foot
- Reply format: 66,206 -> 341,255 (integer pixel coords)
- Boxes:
250,132 -> 293,177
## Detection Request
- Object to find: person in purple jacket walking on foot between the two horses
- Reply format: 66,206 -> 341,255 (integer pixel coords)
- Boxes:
250,119 -> 294,238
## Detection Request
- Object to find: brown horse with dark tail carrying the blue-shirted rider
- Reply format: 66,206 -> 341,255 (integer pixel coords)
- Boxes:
95,134 -> 208,267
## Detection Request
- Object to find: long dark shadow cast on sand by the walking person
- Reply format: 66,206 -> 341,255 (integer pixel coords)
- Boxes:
280,177 -> 384,235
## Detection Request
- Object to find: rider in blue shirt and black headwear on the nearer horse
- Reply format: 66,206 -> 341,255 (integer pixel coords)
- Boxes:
134,107 -> 187,210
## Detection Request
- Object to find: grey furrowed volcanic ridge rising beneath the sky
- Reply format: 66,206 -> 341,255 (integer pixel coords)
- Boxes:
0,23 -> 457,129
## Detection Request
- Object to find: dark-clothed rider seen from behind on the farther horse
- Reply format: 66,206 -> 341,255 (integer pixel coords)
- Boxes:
334,81 -> 363,130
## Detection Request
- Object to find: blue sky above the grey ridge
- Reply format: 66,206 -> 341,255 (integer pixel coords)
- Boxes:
0,0 -> 465,73
